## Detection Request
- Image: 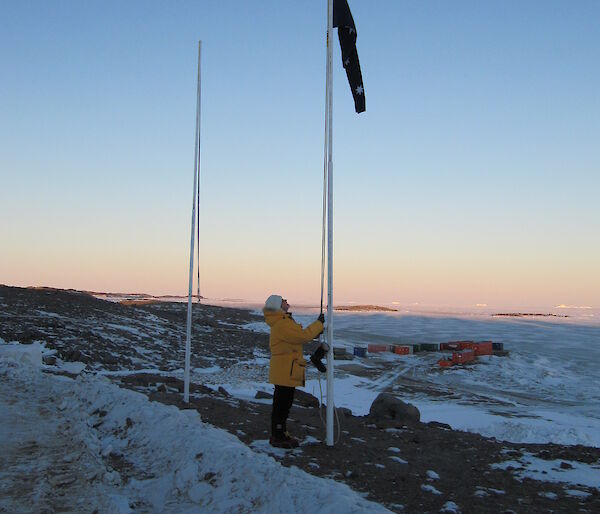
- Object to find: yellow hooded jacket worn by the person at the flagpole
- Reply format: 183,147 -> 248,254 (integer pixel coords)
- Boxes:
263,310 -> 323,387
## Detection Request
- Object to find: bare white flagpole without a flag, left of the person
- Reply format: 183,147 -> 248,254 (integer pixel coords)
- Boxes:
183,41 -> 202,403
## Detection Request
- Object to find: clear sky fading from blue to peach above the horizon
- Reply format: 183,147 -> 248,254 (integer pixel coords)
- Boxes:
0,0 -> 600,306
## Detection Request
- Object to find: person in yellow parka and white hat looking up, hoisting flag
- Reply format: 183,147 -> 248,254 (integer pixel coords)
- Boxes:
263,294 -> 325,448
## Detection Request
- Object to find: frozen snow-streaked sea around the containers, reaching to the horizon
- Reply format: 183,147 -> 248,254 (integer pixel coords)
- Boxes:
243,309 -> 600,447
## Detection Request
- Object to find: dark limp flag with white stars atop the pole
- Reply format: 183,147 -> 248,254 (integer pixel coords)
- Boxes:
333,0 -> 366,113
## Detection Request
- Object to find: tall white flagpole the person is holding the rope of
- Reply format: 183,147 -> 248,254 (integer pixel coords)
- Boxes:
325,0 -> 334,446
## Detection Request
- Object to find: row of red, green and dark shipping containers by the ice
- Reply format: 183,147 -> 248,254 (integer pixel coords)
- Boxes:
352,341 -> 507,367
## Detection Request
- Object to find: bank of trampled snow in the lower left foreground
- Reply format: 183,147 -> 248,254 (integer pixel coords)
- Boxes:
0,340 -> 387,514
